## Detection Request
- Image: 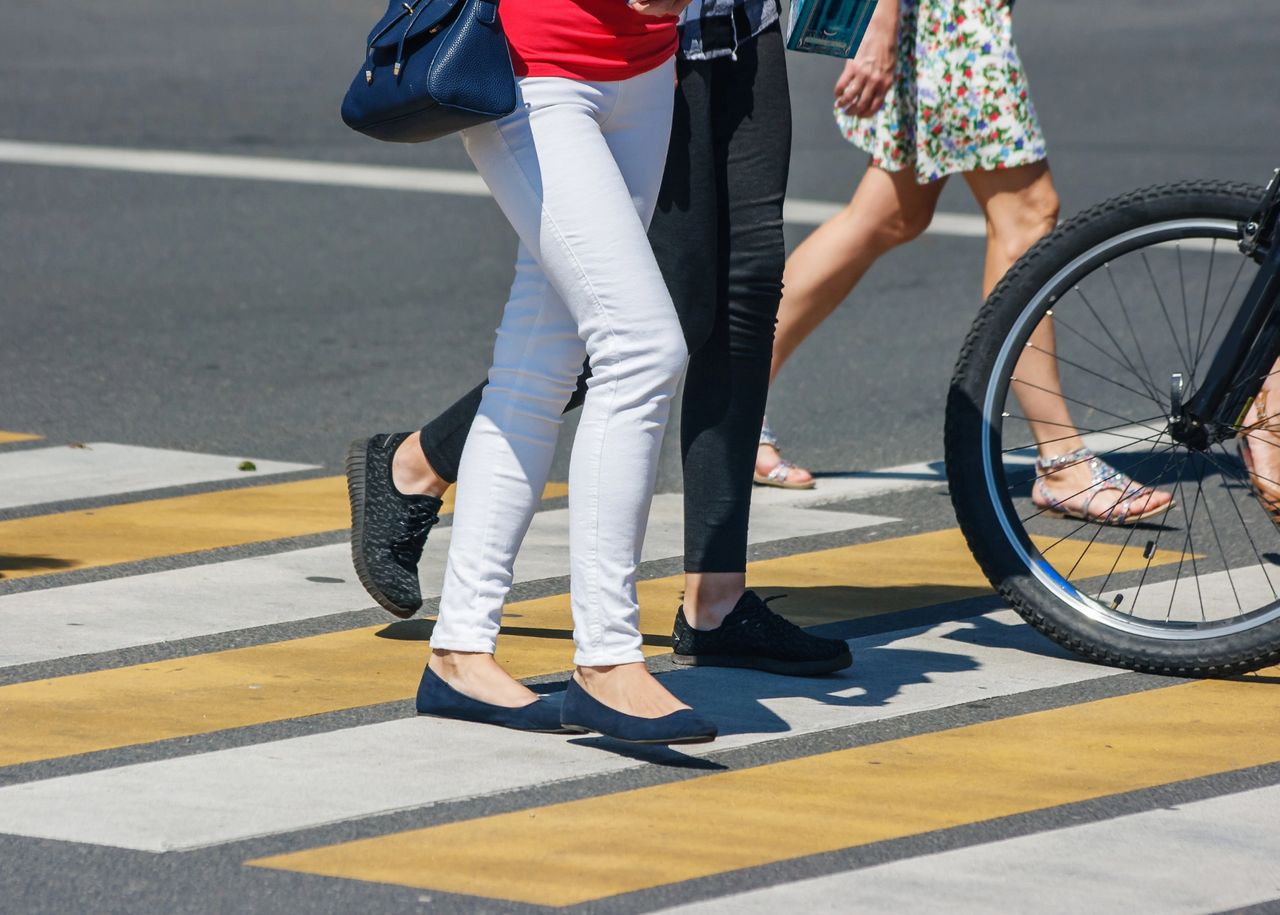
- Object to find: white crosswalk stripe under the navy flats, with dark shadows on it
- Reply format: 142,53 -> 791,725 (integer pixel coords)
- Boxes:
0,610 -> 1119,851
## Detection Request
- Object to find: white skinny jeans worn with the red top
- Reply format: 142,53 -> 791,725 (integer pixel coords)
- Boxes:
431,61 -> 691,667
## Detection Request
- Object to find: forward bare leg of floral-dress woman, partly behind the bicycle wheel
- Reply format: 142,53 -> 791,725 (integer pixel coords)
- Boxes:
965,161 -> 1172,518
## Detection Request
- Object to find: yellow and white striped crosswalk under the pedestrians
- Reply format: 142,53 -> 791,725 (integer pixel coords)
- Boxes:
0,431 -> 1280,912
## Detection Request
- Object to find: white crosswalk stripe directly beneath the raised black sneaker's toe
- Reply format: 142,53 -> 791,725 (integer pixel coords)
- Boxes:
0,496 -> 892,667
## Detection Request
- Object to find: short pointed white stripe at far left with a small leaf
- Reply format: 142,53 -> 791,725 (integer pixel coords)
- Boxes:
0,442 -> 315,508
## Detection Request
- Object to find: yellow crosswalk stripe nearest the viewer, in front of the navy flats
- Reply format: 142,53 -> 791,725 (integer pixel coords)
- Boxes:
250,682 -> 1280,906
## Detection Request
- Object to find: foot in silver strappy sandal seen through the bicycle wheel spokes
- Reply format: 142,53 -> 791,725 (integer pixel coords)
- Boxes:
1032,448 -> 1174,525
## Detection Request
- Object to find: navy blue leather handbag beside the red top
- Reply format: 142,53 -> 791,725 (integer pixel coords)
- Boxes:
342,0 -> 516,143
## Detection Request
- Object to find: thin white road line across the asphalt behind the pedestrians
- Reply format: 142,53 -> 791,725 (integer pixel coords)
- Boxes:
0,139 -> 987,238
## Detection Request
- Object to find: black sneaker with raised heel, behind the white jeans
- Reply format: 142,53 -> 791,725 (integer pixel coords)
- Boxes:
347,433 -> 443,619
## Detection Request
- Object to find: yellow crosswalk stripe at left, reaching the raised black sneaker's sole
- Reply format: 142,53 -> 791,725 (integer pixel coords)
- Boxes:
0,476 -> 567,578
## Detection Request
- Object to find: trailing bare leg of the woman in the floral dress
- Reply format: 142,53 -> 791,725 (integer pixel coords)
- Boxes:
755,165 -> 945,482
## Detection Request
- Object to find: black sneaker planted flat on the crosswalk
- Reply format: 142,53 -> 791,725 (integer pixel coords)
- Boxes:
672,591 -> 854,677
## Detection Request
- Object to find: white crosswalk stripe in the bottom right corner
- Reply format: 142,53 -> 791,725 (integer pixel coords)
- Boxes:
663,787 -> 1280,915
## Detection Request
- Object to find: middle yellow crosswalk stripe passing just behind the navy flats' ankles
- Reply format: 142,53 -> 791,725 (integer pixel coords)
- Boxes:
0,530 -> 1178,765
